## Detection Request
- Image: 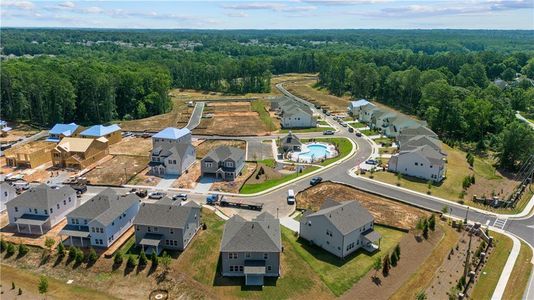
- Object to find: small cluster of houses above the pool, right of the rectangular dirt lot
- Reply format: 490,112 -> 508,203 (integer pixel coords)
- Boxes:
271,96 -> 317,128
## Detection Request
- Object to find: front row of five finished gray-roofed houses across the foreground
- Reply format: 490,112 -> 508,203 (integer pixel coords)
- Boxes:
6,184 -> 380,285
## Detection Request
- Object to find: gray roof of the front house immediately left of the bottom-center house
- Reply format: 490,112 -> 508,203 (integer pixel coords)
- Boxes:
134,201 -> 200,229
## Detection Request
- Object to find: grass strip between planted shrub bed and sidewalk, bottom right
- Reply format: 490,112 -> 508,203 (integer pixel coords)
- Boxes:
471,232 -> 516,299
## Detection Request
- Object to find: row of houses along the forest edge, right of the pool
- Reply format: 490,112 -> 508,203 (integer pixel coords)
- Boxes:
348,99 -> 447,182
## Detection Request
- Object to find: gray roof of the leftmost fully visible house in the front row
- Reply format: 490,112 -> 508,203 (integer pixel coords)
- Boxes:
7,183 -> 76,209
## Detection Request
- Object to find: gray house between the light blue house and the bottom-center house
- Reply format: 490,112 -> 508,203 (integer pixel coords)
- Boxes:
134,197 -> 200,254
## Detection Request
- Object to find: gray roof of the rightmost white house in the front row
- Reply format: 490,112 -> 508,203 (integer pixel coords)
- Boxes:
306,200 -> 374,235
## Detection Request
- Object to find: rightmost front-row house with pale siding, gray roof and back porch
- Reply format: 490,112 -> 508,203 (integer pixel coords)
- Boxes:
300,199 -> 380,259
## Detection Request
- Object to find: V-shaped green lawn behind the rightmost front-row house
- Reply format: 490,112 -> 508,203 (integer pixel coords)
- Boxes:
284,226 -> 405,296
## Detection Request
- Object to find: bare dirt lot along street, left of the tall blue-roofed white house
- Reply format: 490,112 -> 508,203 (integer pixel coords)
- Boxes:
85,155 -> 149,186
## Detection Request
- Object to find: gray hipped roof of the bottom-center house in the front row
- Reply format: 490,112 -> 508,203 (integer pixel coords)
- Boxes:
221,212 -> 282,252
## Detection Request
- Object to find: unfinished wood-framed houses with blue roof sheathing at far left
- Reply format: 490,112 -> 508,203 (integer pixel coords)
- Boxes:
5,123 -> 122,169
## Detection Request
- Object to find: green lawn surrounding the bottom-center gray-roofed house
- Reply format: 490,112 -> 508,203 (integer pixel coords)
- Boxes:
177,210 -> 331,299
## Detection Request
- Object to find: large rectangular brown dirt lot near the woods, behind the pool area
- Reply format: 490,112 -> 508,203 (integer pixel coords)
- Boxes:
193,102 -> 269,136
